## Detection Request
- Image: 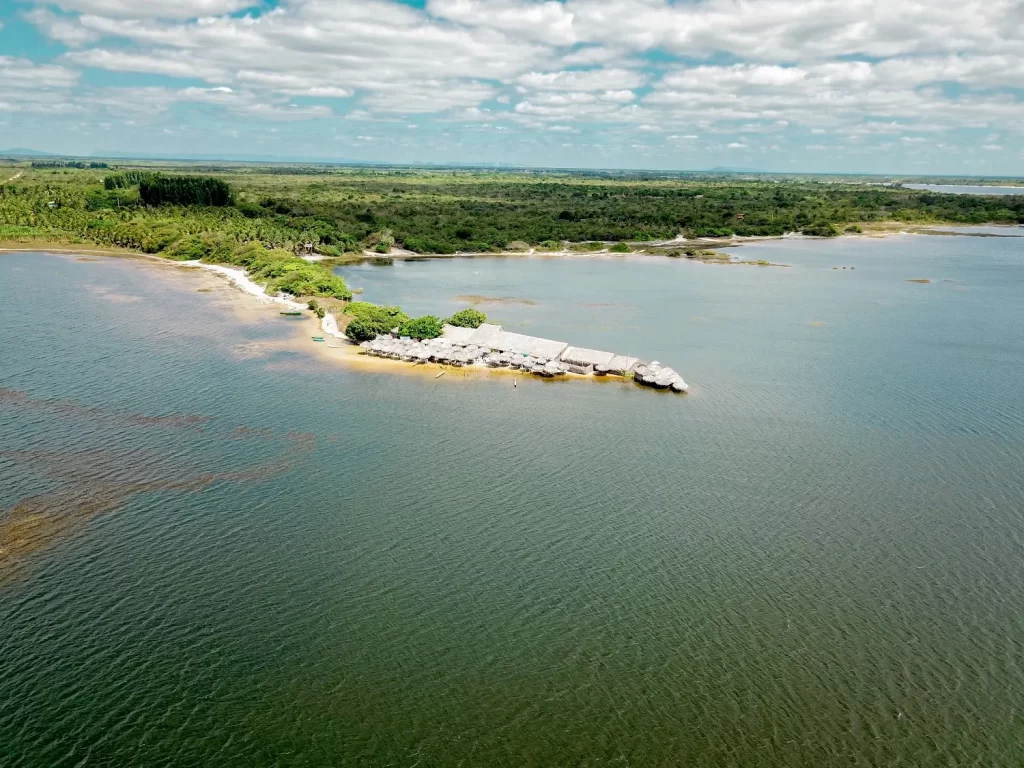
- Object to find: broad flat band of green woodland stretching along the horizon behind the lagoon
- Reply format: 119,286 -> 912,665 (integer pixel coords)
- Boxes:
0,161 -> 1024,258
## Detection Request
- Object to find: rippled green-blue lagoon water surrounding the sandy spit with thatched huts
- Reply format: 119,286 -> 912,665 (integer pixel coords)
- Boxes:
0,237 -> 1024,768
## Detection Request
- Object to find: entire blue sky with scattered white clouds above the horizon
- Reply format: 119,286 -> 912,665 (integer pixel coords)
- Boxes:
0,0 -> 1024,175
